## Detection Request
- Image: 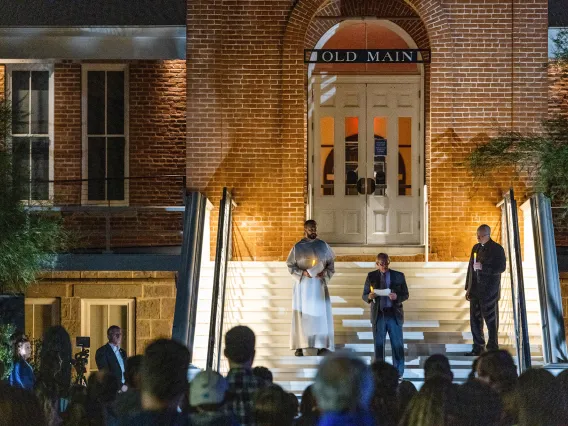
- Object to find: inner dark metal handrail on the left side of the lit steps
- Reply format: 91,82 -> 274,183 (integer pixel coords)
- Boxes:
206,188 -> 233,371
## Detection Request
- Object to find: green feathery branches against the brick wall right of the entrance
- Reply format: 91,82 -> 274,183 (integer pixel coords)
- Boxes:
467,116 -> 568,212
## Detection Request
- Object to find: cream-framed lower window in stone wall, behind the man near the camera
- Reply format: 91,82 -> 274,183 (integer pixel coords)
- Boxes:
81,299 -> 135,372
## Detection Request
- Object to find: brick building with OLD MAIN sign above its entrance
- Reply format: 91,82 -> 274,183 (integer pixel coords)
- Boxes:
0,0 -> 568,374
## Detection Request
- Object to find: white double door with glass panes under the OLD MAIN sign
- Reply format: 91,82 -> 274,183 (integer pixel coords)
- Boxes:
310,78 -> 421,244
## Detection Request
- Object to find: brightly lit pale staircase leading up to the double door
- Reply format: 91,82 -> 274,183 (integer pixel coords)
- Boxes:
190,262 -> 542,394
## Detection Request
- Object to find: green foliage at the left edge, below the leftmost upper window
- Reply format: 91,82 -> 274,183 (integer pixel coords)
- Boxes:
0,100 -> 68,293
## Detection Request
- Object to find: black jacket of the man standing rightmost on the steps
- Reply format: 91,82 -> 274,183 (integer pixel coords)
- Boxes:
465,239 -> 507,303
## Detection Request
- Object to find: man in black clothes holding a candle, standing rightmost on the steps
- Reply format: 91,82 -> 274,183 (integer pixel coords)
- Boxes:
465,225 -> 507,356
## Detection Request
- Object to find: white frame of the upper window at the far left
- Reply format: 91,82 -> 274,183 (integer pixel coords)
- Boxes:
5,62 -> 55,205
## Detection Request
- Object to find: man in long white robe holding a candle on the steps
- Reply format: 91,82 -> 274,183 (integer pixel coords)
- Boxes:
286,220 -> 335,356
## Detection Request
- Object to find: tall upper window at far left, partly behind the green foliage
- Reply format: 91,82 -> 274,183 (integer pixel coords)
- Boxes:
7,64 -> 53,201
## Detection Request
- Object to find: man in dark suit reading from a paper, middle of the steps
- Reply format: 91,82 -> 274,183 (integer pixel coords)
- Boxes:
363,253 -> 408,378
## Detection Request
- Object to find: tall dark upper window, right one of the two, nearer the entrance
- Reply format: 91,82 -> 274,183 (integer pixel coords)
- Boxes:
83,65 -> 128,204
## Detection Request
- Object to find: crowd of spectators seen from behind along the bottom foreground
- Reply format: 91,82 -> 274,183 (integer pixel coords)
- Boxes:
0,326 -> 568,426
